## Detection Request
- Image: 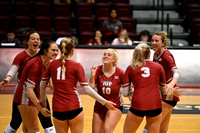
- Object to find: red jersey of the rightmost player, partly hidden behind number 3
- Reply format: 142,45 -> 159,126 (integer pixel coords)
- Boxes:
153,50 -> 179,101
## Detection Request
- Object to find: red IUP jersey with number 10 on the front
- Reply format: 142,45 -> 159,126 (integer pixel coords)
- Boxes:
94,65 -> 124,109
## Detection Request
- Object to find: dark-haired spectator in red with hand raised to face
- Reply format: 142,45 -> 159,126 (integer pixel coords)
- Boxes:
88,29 -> 108,45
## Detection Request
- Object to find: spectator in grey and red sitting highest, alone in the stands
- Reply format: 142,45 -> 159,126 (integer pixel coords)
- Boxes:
102,9 -> 123,42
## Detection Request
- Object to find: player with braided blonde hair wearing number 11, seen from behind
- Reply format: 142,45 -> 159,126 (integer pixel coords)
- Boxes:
40,38 -> 115,133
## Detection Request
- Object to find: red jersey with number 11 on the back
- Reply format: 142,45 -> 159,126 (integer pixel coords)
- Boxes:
42,59 -> 89,112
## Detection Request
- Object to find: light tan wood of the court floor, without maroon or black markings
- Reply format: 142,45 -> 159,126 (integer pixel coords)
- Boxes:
0,94 -> 200,133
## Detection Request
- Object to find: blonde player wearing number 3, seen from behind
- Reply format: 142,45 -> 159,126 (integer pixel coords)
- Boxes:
123,44 -> 166,133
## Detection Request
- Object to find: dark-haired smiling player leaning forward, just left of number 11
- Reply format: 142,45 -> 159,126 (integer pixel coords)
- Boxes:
13,41 -> 58,133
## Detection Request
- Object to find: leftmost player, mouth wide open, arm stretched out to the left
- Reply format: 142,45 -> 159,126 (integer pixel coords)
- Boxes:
0,31 -> 55,133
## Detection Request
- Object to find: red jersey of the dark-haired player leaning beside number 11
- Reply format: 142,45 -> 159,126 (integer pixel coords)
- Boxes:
14,56 -> 46,106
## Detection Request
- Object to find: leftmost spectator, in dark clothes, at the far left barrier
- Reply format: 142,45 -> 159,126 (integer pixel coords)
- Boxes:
1,30 -> 21,46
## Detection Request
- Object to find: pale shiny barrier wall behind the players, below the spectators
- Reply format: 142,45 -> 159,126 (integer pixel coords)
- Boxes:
0,48 -> 200,83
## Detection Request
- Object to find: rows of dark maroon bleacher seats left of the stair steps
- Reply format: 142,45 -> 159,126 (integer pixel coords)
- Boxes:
0,0 -> 136,44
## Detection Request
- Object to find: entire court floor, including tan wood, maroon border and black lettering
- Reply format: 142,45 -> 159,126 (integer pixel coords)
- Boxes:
0,84 -> 200,133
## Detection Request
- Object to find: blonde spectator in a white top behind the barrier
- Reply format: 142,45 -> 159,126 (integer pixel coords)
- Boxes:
112,29 -> 133,45
